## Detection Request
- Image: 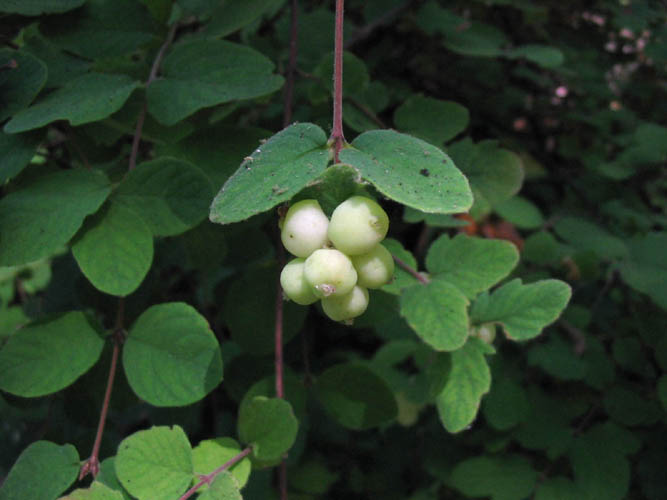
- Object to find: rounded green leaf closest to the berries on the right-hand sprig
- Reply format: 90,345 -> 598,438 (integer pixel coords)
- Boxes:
401,279 -> 469,351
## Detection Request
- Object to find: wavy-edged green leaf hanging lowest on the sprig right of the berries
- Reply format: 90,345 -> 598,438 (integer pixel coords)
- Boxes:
435,338 -> 493,432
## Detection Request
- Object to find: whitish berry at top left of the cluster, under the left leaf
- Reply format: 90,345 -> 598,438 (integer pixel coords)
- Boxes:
280,200 -> 329,258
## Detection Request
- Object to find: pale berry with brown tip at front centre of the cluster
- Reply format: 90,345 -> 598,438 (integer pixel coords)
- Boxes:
303,248 -> 357,297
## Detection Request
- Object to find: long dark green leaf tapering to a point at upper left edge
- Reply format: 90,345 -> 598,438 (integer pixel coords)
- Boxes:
4,73 -> 139,134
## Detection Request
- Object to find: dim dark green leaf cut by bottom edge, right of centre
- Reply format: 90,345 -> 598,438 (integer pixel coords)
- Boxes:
449,455 -> 536,500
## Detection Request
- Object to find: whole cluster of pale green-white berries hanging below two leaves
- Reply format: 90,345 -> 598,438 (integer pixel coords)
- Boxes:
280,196 -> 394,322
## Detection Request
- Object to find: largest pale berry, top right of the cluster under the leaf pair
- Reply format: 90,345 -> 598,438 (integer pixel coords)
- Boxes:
328,196 -> 389,255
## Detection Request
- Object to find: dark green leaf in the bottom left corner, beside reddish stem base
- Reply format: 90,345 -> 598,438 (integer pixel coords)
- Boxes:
0,441 -> 81,500
